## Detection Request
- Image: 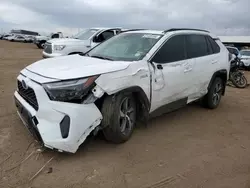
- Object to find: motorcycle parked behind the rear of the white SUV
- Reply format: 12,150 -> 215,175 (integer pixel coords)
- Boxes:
229,57 -> 247,88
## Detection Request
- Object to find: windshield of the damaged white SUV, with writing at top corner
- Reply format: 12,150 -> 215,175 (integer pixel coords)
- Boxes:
87,33 -> 162,61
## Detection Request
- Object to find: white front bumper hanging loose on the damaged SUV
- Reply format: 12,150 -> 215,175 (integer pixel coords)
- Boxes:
14,75 -> 102,153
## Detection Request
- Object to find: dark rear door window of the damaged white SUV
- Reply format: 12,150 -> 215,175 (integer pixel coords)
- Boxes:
187,35 -> 208,58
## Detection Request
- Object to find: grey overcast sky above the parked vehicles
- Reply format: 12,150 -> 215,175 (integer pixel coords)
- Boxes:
0,0 -> 250,35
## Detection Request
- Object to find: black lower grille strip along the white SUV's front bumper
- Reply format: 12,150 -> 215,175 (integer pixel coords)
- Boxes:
14,97 -> 43,145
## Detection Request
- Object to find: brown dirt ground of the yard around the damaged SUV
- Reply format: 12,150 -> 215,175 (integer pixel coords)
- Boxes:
0,41 -> 250,188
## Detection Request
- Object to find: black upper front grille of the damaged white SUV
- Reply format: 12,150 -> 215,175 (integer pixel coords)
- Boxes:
17,80 -> 38,110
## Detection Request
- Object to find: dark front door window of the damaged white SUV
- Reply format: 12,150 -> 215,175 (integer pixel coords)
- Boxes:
152,35 -> 186,63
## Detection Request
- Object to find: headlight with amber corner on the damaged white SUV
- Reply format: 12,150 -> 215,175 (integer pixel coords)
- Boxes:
43,76 -> 98,102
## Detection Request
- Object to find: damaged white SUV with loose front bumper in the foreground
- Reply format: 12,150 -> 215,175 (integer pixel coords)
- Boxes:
14,29 -> 230,153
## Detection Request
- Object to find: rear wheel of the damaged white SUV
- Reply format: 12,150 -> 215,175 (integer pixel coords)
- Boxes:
202,77 -> 225,109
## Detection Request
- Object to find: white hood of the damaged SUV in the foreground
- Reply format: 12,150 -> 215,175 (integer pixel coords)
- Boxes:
25,55 -> 130,80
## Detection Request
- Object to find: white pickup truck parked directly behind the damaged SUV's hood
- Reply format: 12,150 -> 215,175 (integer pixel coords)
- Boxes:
43,28 -> 121,58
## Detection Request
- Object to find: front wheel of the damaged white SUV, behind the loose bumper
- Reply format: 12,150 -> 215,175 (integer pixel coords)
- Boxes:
101,93 -> 137,144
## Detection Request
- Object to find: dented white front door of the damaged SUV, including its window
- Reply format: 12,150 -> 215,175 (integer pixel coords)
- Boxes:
150,35 -> 194,114
